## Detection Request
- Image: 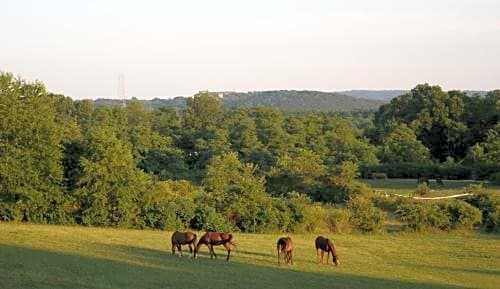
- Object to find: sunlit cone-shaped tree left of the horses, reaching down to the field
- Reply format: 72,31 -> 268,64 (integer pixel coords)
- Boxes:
75,126 -> 148,227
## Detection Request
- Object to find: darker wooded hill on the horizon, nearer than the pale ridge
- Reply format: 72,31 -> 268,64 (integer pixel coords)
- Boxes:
94,90 -> 386,111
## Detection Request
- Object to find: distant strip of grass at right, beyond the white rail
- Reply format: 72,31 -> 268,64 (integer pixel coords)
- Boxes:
361,179 -> 500,196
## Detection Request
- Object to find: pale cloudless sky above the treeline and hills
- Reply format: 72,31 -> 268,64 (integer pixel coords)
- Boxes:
0,0 -> 500,98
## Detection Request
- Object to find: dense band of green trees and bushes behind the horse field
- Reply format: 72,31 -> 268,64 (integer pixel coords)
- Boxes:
0,73 -> 500,232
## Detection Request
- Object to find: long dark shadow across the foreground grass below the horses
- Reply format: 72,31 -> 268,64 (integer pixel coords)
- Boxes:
0,245 -> 463,289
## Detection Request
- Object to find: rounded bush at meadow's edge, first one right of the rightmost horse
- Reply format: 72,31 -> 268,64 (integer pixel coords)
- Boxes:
347,197 -> 387,232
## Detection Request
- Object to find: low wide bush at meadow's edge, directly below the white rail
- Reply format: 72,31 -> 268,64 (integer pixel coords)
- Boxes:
395,200 -> 450,232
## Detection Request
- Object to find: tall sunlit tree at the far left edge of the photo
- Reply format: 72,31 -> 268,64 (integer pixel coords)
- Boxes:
0,73 -> 65,223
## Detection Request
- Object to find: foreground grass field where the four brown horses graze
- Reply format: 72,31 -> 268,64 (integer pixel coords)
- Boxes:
0,223 -> 500,289
